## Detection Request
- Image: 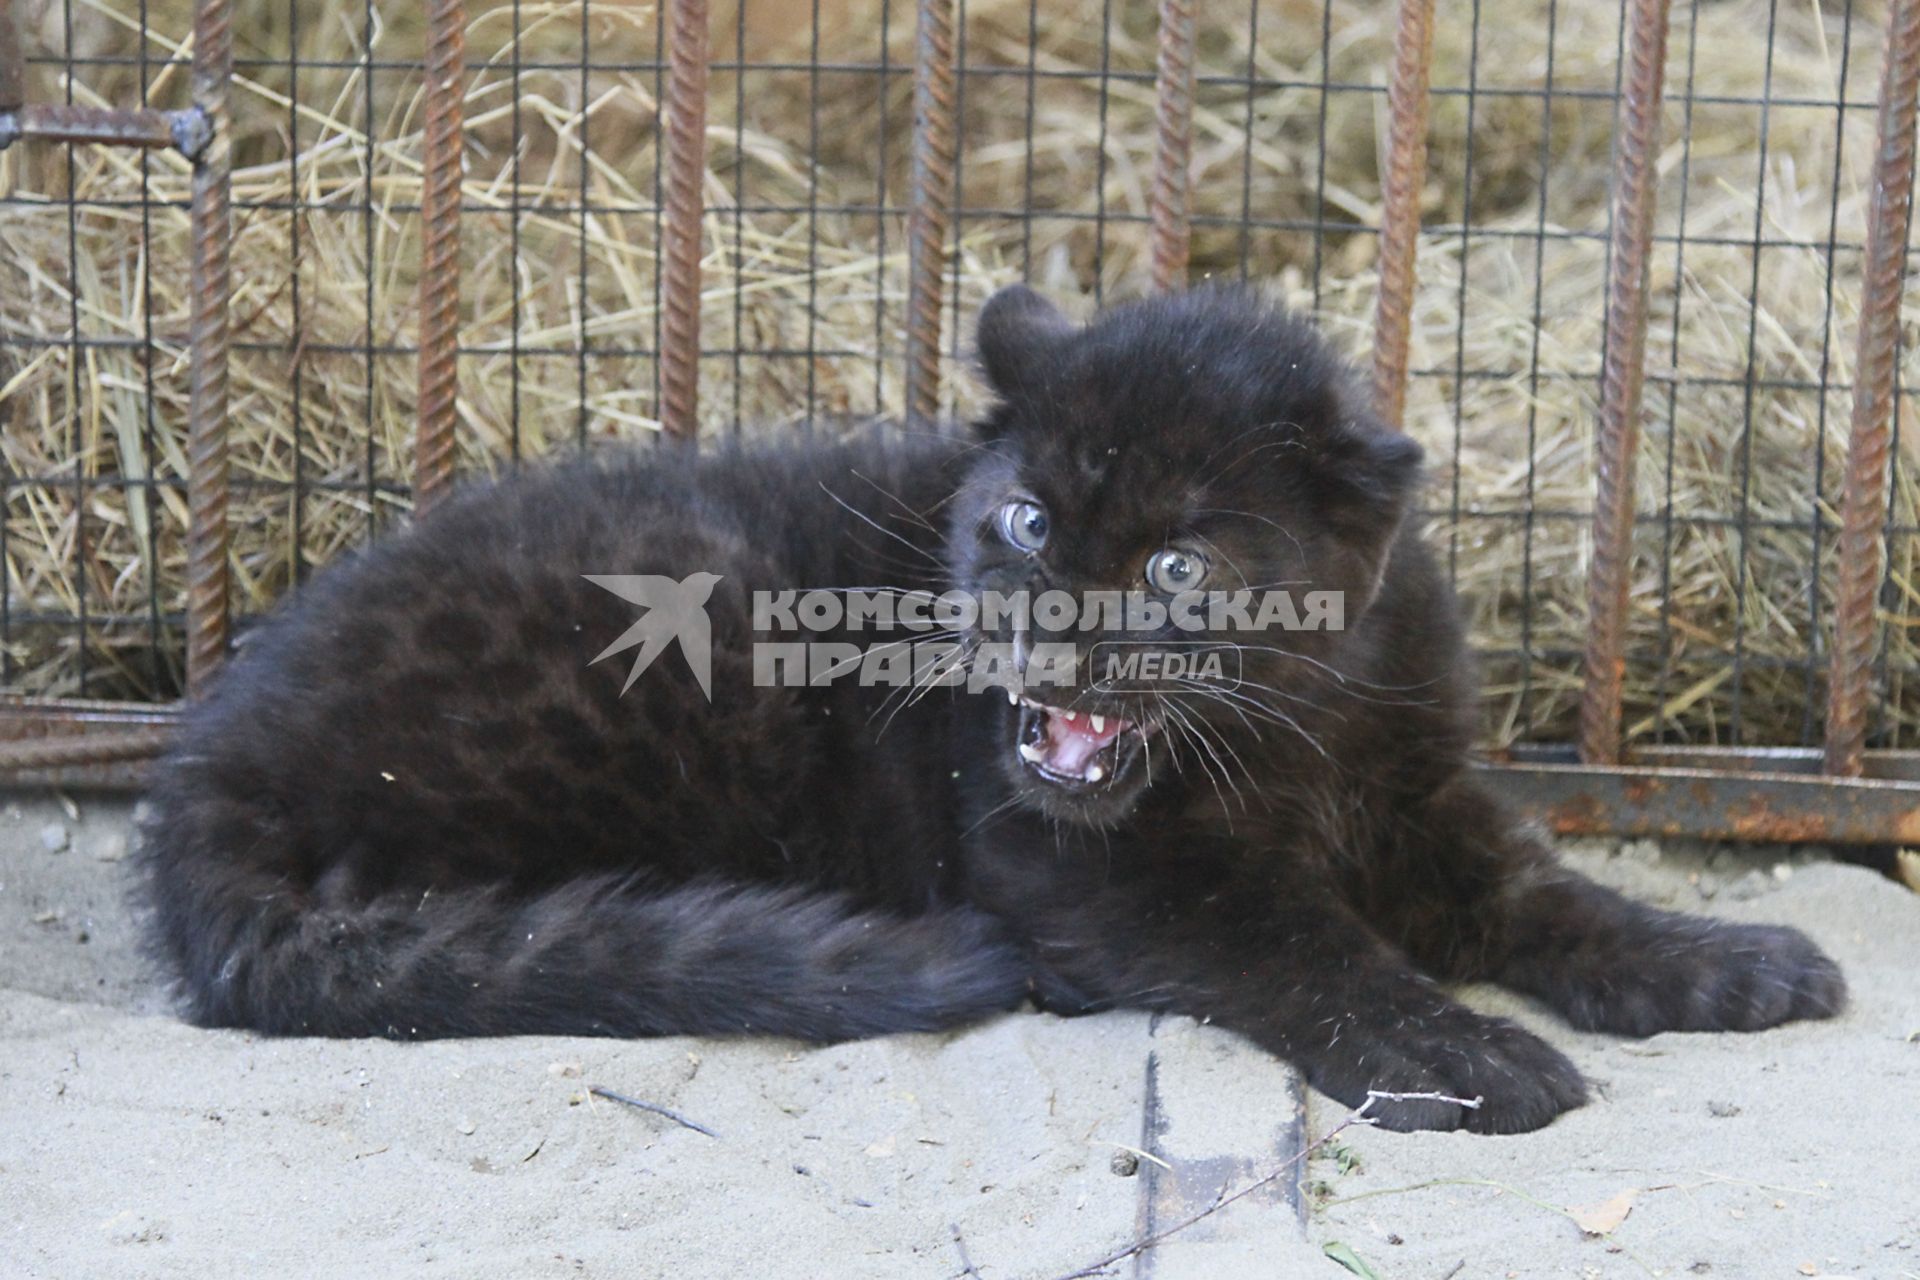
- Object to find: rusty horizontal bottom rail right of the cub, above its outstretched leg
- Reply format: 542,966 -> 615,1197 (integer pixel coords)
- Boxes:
1484,764 -> 1920,844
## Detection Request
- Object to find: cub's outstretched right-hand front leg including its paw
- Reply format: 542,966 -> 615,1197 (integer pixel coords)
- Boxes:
1398,777 -> 1847,1036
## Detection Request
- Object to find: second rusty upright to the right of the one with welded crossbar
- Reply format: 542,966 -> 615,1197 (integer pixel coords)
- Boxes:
660,0 -> 708,441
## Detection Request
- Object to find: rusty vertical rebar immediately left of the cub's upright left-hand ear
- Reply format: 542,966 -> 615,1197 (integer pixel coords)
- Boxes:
906,0 -> 954,422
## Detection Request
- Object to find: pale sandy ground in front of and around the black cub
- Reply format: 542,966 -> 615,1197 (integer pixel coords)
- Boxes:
0,794 -> 1920,1280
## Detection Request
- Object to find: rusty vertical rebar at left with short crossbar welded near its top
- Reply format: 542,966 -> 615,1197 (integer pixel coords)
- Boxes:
186,0 -> 234,693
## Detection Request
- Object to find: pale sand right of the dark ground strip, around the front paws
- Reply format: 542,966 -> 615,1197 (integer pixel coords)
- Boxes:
1308,842 -> 1920,1280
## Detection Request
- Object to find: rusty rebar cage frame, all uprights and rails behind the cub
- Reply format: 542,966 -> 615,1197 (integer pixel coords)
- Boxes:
11,0 -> 1920,842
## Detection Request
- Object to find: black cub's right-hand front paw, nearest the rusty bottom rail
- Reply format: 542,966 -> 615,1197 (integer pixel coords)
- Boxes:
1563,915 -> 1847,1036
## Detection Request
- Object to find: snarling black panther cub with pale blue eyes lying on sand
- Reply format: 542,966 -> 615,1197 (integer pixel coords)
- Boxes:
142,288 -> 1845,1132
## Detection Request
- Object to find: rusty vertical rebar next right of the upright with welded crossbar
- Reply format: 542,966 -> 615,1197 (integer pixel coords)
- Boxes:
413,0 -> 467,514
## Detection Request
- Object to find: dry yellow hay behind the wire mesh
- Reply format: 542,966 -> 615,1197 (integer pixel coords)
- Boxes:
0,0 -> 1920,743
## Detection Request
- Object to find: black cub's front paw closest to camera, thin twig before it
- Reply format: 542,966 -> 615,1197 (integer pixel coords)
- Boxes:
1306,1007 -> 1586,1134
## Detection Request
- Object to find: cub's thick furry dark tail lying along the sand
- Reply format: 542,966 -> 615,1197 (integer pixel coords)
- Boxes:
146,833 -> 1027,1040
